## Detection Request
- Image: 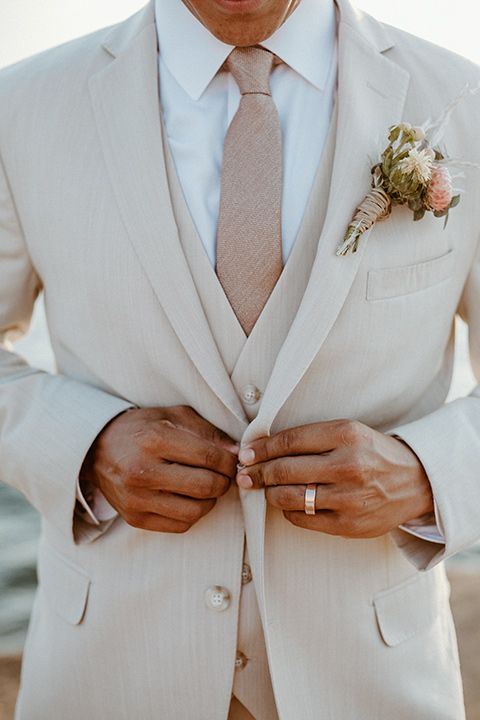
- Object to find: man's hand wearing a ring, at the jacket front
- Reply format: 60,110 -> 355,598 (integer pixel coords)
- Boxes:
237,420 -> 433,538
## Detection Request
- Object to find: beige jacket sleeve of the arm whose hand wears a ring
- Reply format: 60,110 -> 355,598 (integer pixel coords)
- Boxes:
389,231 -> 480,570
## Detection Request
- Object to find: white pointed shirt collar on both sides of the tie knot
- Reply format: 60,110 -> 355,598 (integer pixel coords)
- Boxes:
155,0 -> 336,100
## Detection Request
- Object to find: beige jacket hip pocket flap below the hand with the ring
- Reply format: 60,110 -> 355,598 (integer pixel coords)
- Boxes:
373,572 -> 448,647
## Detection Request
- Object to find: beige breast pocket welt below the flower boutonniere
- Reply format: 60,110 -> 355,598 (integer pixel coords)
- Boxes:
367,250 -> 455,301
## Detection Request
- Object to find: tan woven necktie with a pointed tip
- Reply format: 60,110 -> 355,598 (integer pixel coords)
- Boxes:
217,47 -> 282,335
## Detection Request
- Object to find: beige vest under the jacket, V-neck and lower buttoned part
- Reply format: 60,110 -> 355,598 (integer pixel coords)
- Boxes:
163,105 -> 337,720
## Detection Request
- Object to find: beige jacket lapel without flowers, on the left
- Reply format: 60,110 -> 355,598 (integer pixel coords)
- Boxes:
90,3 -> 245,422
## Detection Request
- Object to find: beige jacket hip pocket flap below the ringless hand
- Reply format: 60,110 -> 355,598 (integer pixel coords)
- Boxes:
38,547 -> 91,625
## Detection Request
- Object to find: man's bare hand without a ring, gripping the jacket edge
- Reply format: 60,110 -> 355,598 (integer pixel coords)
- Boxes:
80,406 -> 238,533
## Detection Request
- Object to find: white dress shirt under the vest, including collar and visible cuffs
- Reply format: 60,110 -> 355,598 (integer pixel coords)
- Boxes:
79,0 -> 442,542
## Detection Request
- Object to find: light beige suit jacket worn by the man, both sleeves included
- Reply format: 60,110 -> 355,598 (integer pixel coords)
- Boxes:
0,0 -> 480,720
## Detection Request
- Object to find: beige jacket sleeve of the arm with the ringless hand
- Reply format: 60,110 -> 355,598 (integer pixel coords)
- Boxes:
0,153 -> 132,542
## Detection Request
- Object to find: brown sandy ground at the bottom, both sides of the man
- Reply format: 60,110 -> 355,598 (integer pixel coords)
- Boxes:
0,572 -> 480,720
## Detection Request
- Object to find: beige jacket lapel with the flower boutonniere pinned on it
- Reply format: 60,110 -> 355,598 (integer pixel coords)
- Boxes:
244,0 -> 409,442
